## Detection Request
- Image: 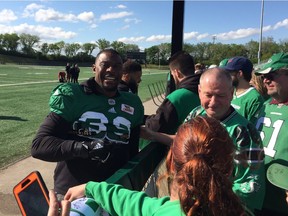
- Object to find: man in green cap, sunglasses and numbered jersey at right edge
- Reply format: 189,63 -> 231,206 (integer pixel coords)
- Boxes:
256,53 -> 288,216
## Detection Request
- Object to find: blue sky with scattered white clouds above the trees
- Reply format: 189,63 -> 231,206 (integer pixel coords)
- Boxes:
0,0 -> 288,50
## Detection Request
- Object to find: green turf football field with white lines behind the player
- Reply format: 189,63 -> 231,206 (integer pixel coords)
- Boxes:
0,65 -> 168,168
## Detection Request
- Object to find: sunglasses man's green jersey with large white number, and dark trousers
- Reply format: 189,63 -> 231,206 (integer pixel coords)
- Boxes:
256,100 -> 288,215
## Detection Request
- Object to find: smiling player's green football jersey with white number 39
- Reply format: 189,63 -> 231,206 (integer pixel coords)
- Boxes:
49,84 -> 144,144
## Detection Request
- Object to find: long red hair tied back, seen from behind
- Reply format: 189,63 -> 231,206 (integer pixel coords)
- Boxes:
166,116 -> 244,216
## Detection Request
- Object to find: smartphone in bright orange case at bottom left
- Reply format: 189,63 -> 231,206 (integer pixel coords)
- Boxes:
13,171 -> 49,216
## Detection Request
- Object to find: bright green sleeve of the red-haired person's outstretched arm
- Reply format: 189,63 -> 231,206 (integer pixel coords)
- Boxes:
85,182 -> 170,216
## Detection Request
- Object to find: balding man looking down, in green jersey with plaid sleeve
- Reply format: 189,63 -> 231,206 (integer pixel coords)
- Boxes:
186,68 -> 265,211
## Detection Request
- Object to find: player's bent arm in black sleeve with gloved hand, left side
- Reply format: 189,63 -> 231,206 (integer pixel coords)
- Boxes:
31,112 -> 111,162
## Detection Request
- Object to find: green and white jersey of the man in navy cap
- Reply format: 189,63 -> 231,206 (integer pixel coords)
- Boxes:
231,87 -> 264,124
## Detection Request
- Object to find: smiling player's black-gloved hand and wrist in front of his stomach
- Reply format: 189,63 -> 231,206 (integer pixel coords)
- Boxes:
73,139 -> 113,163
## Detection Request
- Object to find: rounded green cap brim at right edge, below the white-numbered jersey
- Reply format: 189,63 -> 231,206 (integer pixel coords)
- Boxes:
266,163 -> 288,190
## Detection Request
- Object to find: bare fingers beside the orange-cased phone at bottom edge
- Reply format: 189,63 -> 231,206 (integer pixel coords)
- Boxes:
47,190 -> 71,216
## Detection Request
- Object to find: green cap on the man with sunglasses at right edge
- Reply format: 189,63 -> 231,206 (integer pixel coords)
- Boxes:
256,52 -> 288,75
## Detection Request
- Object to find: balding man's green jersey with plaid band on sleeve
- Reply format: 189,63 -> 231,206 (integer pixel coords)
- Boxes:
185,106 -> 265,211
